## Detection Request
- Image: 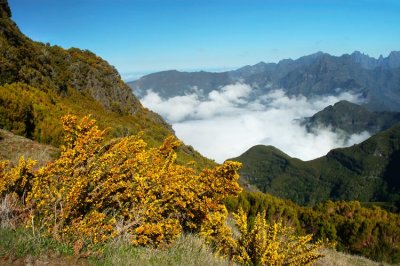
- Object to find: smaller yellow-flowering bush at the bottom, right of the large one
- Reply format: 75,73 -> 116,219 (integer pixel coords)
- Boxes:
233,209 -> 323,265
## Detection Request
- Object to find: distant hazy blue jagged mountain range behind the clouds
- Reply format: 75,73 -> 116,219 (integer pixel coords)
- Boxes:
128,51 -> 400,111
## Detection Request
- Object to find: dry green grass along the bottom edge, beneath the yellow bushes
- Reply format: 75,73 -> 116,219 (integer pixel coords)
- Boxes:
0,225 -> 396,266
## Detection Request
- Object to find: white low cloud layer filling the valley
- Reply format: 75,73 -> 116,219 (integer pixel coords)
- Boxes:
141,83 -> 369,162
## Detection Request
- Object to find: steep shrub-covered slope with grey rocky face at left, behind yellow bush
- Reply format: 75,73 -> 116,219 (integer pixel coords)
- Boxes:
0,1 -> 213,168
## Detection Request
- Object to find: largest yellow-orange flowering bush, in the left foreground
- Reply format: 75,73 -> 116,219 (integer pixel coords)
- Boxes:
0,116 -> 241,246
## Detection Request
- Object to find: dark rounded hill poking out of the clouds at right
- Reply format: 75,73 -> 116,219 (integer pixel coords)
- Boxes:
304,101 -> 400,134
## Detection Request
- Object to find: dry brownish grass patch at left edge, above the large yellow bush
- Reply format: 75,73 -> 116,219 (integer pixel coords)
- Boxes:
0,129 -> 58,166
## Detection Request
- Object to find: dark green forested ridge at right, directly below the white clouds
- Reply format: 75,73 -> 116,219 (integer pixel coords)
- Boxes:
233,124 -> 400,208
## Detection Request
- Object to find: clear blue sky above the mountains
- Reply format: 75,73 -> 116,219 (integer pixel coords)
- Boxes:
9,0 -> 400,79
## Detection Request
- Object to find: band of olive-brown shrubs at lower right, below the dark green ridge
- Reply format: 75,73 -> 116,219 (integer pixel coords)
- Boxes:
225,191 -> 400,265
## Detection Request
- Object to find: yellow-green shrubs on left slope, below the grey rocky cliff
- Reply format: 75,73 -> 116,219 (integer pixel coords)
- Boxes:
0,83 -> 215,169
